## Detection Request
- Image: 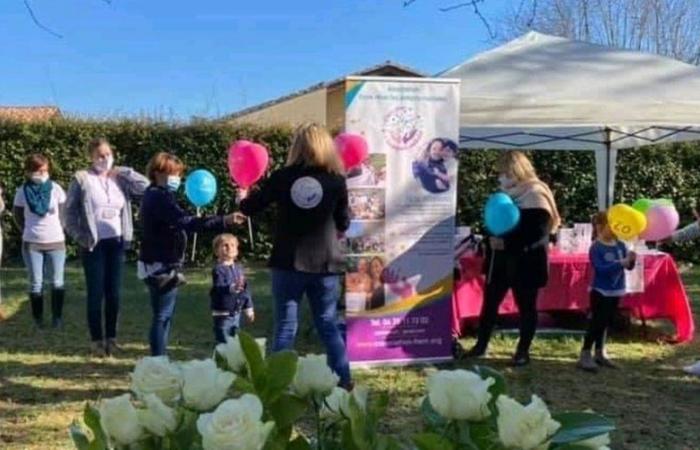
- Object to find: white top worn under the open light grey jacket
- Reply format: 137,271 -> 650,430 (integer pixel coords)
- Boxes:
87,173 -> 126,240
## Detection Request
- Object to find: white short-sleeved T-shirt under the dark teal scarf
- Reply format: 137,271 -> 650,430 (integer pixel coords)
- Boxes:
14,181 -> 66,244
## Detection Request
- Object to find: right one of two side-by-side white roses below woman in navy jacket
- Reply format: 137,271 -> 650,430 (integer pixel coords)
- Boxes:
181,359 -> 236,411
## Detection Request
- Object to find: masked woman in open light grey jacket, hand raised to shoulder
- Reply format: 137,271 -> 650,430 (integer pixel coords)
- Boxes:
66,138 -> 148,356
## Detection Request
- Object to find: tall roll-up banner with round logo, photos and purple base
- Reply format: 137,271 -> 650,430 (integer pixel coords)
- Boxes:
343,77 -> 459,366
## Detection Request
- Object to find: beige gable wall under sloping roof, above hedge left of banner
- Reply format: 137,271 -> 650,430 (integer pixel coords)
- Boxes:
231,87 -> 327,126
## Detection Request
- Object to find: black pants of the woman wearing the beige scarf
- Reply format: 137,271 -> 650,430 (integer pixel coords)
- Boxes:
476,283 -> 539,354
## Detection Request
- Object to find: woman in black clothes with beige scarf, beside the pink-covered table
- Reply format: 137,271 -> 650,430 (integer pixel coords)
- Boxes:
466,151 -> 561,366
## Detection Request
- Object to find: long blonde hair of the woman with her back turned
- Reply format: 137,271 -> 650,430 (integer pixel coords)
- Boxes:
287,123 -> 345,175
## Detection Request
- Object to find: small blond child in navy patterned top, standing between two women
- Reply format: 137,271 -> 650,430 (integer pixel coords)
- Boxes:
210,233 -> 255,344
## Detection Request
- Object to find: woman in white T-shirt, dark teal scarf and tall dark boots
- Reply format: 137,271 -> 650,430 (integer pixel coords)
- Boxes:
14,153 -> 66,328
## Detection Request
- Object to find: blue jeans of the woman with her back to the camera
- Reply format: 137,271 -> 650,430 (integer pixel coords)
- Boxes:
272,269 -> 350,385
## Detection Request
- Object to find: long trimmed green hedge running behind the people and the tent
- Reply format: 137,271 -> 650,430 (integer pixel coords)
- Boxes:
0,119 -> 700,262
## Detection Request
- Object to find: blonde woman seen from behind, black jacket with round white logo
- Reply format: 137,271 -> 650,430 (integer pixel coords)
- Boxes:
239,124 -> 352,389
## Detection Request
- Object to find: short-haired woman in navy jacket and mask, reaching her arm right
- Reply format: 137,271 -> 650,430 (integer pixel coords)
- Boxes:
138,152 -> 234,356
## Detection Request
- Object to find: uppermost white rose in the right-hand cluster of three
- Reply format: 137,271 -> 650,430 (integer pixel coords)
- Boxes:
428,369 -> 496,422
